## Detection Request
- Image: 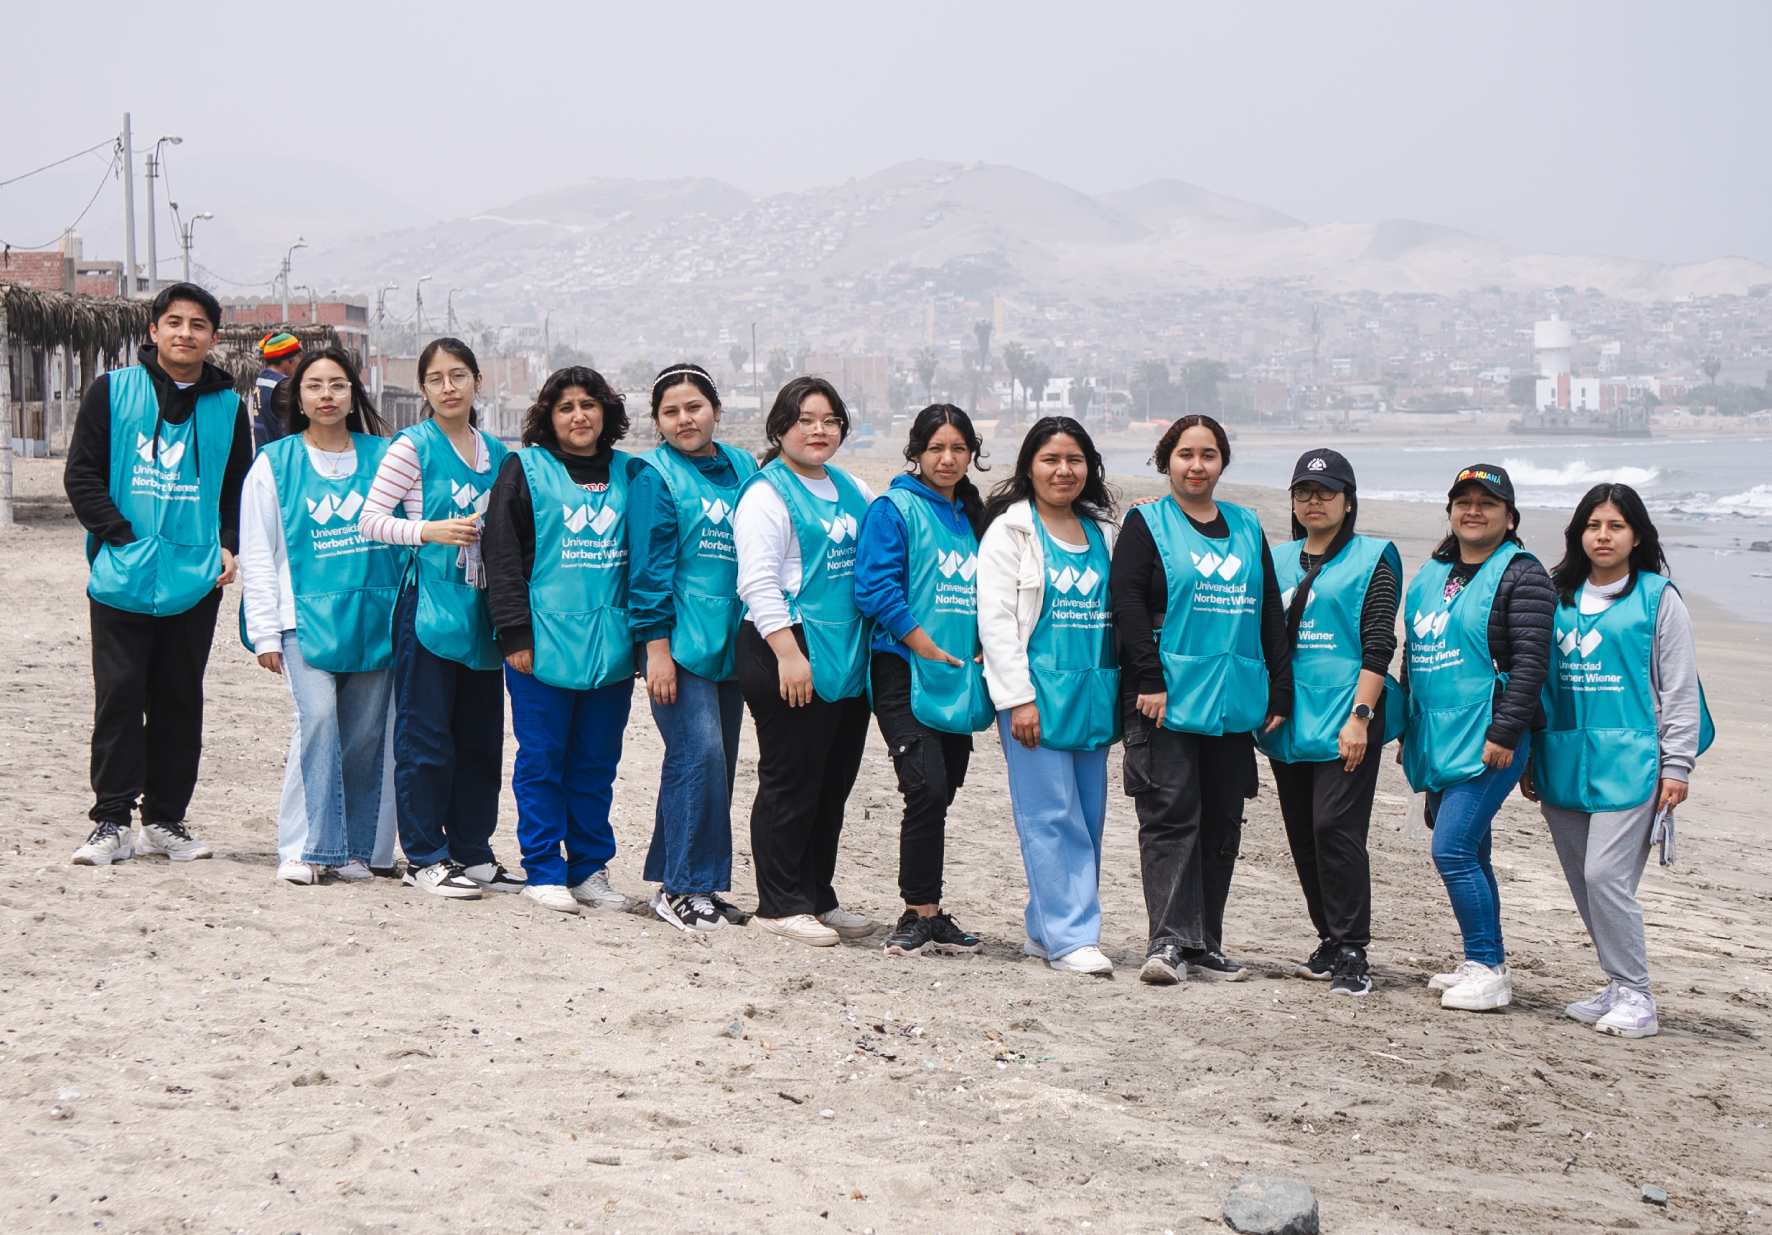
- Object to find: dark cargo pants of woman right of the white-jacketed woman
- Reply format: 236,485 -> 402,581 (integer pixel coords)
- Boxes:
1120,700 -> 1258,955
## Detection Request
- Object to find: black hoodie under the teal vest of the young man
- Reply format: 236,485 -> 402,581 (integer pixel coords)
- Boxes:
62,347 -> 253,553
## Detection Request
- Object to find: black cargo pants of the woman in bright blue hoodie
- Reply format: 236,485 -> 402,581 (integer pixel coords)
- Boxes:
872,652 -> 973,905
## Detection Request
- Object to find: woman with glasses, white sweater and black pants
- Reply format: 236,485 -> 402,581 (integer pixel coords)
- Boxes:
734,377 -> 874,948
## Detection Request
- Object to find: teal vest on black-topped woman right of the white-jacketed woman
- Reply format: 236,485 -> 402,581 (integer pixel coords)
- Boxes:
1136,496 -> 1267,735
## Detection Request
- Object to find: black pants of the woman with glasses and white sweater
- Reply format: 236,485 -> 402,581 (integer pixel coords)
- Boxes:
739,622 -> 868,918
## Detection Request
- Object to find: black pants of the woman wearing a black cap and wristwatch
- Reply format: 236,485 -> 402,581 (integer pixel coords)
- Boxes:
1267,698 -> 1384,948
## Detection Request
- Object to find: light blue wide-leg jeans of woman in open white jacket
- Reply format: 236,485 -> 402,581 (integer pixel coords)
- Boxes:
998,711 -> 1108,957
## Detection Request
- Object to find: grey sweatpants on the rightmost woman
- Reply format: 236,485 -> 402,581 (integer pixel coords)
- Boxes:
1540,800 -> 1659,994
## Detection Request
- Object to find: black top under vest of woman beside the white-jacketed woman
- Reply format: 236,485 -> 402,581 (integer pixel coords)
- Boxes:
1108,498 -> 1292,716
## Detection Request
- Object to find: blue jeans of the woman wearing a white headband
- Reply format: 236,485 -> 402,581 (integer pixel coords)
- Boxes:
643,664 -> 744,897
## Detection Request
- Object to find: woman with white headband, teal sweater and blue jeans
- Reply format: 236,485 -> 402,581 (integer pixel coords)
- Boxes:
627,363 -> 757,932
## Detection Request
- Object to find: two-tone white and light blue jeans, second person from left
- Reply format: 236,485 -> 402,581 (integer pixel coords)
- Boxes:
276,631 -> 393,866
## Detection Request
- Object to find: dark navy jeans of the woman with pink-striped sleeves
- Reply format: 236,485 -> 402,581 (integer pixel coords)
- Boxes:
393,586 -> 505,868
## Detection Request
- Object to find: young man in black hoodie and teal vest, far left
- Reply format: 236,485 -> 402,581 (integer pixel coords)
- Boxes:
62,284 -> 252,866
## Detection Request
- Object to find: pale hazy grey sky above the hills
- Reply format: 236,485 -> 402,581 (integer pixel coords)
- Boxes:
10,0 -> 1772,262
